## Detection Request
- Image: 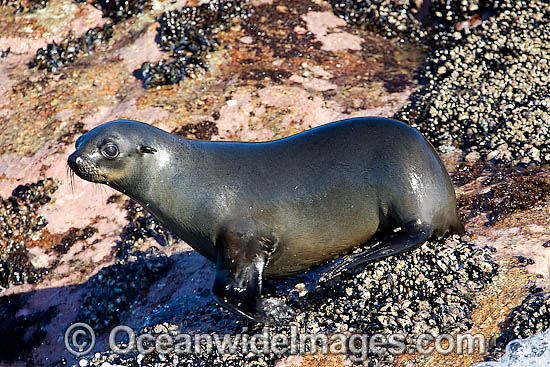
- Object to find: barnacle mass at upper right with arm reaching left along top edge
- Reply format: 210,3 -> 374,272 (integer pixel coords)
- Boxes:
331,0 -> 550,165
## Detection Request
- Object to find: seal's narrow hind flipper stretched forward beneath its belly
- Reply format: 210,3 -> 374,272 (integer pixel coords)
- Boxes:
325,221 -> 433,279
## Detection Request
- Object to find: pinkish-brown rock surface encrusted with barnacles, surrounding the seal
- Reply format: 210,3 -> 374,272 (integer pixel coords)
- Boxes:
0,0 -> 550,366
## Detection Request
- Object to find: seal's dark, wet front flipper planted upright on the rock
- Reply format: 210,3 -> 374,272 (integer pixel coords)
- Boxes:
212,231 -> 273,323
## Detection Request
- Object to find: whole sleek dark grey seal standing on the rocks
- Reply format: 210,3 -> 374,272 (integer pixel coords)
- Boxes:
68,117 -> 464,322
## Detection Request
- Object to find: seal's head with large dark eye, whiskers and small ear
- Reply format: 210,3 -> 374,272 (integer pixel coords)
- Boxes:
68,120 -> 160,191
